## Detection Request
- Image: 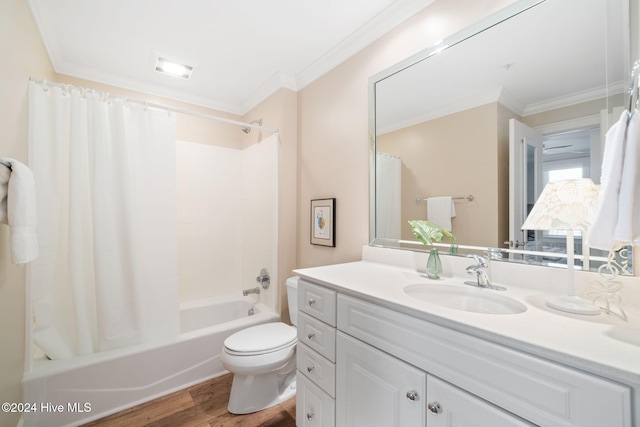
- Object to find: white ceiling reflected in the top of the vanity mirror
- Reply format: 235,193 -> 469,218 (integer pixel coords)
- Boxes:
376,0 -> 630,134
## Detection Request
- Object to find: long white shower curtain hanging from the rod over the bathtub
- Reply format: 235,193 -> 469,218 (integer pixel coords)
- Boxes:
27,82 -> 179,359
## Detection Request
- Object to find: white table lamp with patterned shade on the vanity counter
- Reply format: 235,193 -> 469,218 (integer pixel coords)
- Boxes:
522,178 -> 600,314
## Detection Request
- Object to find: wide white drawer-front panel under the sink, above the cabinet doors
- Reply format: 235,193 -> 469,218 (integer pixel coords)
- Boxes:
338,295 -> 631,427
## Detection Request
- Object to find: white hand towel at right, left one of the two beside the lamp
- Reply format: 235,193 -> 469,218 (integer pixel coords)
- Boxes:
587,111 -> 629,251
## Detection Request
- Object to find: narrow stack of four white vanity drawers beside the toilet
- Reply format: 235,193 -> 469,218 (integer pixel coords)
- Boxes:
296,280 -> 336,427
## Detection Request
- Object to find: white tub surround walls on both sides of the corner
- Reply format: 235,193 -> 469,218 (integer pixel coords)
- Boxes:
176,138 -> 277,308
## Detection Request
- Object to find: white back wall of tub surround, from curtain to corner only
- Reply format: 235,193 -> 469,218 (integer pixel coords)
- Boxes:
176,141 -> 242,301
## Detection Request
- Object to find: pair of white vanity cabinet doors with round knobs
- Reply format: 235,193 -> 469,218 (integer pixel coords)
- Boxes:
336,332 -> 532,427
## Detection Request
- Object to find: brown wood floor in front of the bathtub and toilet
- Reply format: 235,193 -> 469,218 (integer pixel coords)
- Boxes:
82,374 -> 296,427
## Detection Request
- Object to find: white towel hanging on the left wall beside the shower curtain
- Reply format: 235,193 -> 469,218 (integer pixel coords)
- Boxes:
0,158 -> 38,264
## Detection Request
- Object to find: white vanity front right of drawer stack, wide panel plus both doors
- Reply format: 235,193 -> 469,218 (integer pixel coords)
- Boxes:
335,294 -> 631,427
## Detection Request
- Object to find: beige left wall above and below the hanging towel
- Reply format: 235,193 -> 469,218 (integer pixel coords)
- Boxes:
0,0 -> 54,426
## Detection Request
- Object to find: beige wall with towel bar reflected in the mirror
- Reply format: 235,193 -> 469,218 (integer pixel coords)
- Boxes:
378,103 -> 509,247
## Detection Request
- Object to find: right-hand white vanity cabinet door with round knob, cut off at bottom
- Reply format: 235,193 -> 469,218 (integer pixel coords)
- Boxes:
427,375 -> 534,427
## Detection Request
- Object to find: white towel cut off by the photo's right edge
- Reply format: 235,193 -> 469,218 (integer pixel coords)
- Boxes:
613,112 -> 640,245
